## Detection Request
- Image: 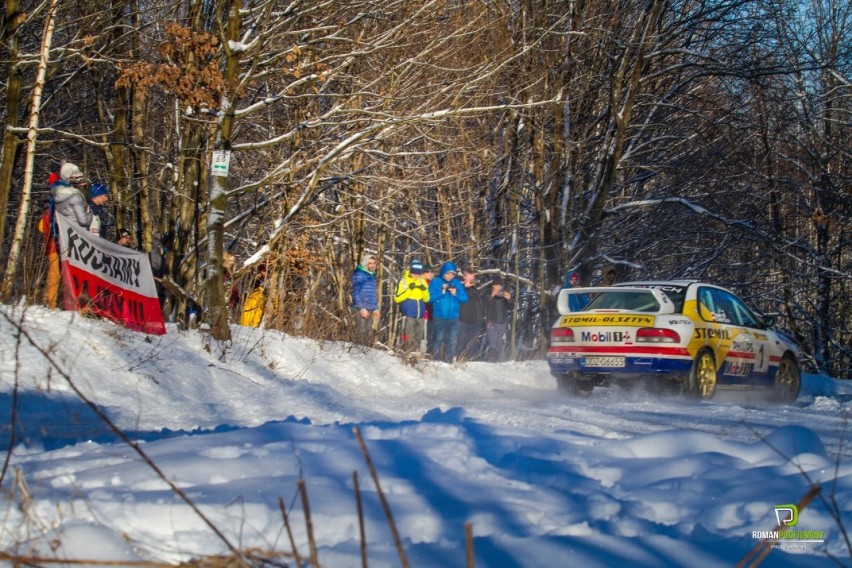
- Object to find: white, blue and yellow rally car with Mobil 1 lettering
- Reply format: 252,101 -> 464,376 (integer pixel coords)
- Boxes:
547,280 -> 801,404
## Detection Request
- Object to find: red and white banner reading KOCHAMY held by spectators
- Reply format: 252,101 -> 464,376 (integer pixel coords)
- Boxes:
56,213 -> 166,335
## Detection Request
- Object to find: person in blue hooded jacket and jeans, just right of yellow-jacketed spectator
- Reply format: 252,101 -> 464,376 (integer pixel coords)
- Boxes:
429,262 -> 467,363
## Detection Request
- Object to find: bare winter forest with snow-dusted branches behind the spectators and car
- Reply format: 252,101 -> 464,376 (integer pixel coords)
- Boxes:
0,0 -> 852,378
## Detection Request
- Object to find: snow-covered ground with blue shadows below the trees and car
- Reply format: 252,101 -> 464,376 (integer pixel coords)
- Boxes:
0,306 -> 852,568
